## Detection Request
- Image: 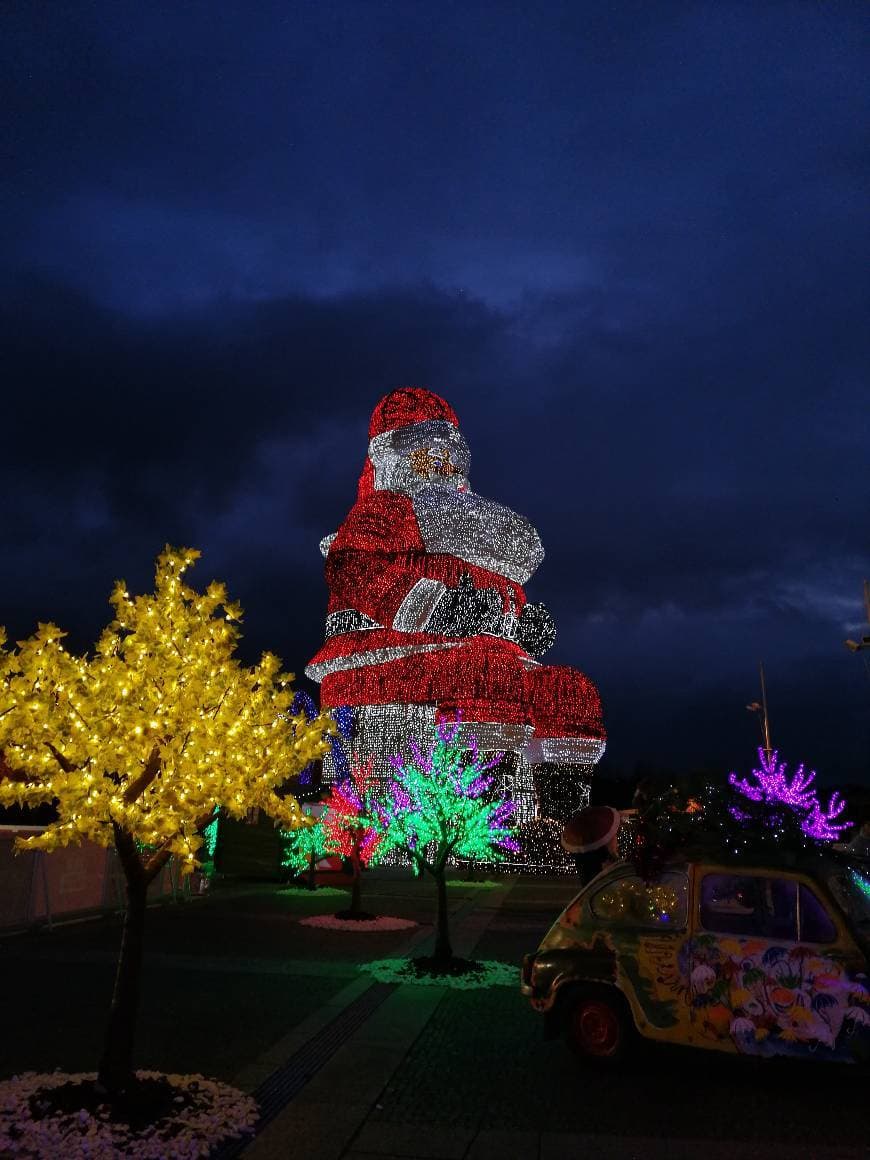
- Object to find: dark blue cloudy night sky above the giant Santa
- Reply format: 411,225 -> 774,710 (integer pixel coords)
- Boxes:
0,0 -> 870,783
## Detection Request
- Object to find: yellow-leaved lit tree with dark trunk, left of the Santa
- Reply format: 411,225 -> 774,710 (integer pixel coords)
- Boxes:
0,546 -> 333,1096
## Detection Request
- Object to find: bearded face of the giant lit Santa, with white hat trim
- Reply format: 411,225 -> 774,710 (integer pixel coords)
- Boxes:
369,419 -> 471,495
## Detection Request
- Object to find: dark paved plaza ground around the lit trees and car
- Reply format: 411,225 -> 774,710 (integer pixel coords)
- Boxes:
0,870 -> 870,1160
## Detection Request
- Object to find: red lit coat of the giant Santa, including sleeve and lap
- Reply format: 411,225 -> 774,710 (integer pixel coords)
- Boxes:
306,491 -> 604,738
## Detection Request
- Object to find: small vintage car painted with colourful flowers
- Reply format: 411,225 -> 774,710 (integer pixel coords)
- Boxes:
521,854 -> 870,1063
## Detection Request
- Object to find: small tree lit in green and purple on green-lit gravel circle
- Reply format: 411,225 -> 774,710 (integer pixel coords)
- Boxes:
369,722 -> 519,970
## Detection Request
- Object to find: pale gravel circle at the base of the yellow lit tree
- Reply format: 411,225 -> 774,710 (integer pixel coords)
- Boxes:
0,1071 -> 260,1160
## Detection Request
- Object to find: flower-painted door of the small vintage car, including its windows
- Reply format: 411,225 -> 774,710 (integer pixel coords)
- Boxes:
689,865 -> 861,1059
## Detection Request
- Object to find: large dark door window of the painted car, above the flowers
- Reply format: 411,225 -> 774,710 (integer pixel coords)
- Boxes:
701,873 -> 798,942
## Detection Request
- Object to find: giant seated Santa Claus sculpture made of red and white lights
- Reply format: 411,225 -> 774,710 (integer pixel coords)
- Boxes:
305,387 -> 606,864
